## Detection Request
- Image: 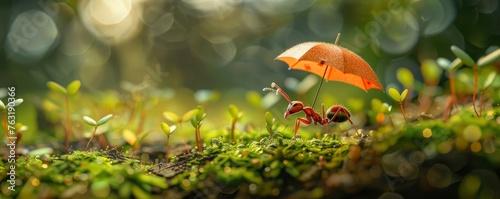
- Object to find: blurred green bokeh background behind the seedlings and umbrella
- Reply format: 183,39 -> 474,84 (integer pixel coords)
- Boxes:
0,0 -> 500,145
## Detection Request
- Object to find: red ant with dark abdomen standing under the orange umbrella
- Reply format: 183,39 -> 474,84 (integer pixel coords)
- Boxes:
262,82 -> 360,140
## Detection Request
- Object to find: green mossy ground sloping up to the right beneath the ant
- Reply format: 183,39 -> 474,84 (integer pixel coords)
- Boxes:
0,107 -> 500,198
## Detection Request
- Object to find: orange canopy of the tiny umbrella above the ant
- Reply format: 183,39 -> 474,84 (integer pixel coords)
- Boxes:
276,42 -> 383,91
